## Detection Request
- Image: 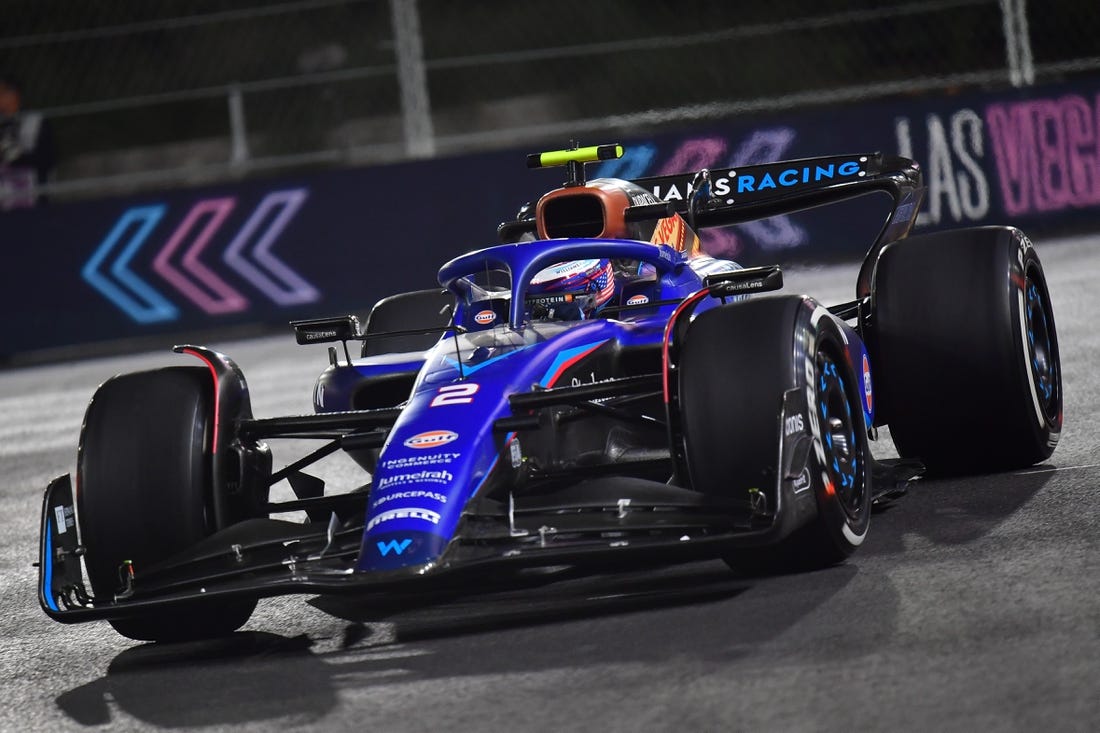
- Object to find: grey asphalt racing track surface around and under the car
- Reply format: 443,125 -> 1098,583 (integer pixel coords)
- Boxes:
0,238 -> 1100,732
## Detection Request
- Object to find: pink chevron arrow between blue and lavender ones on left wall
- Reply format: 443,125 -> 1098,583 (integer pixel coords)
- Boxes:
153,197 -> 249,314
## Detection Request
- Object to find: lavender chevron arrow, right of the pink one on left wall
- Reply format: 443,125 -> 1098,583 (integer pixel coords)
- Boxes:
222,188 -> 321,306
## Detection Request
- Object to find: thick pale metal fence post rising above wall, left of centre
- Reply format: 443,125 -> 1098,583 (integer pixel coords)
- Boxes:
389,0 -> 436,157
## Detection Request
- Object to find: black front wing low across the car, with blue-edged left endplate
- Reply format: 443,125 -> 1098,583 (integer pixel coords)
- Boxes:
39,474 -> 789,623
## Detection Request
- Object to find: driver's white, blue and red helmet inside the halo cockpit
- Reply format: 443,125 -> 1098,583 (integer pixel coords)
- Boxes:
527,259 -> 615,320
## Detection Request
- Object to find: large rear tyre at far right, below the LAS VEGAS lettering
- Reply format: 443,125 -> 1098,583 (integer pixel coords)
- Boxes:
869,227 -> 1062,473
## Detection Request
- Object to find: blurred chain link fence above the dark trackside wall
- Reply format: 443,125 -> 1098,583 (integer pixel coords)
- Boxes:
0,0 -> 1100,199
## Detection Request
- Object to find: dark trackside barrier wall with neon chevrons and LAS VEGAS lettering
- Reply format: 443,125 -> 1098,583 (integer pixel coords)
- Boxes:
0,80 -> 1100,360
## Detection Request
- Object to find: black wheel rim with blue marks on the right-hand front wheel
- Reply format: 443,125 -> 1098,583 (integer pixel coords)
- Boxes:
816,352 -> 865,519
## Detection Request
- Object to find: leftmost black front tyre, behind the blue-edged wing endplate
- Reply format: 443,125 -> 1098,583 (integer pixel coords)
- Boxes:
77,367 -> 256,642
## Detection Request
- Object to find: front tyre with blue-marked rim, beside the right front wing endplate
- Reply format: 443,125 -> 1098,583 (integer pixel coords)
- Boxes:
679,296 -> 871,575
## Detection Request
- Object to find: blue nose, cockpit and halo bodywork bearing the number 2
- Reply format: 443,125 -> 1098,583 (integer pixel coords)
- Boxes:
315,239 -> 871,571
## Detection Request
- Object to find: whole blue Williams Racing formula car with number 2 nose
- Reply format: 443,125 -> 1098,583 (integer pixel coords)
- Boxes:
39,145 -> 1062,641
